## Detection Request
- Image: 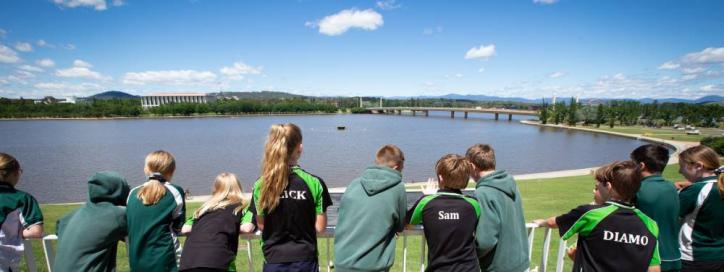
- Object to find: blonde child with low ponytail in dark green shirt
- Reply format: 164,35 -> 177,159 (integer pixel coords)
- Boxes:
126,150 -> 186,271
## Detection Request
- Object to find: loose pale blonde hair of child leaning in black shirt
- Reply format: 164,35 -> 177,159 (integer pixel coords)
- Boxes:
194,172 -> 246,219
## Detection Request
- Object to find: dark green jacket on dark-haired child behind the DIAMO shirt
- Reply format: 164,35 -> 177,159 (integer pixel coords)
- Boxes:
635,175 -> 681,271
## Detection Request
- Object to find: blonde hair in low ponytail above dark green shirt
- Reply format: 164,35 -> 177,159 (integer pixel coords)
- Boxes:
137,150 -> 176,205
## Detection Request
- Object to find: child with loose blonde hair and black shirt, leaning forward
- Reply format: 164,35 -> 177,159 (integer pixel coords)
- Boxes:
180,173 -> 254,272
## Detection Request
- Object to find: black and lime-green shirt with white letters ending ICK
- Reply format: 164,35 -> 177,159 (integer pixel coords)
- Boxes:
252,166 -> 328,263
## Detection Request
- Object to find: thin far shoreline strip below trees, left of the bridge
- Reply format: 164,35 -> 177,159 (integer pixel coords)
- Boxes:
0,112 -> 342,121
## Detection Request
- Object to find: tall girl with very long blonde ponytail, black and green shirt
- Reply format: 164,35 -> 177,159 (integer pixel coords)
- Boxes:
253,124 -> 331,271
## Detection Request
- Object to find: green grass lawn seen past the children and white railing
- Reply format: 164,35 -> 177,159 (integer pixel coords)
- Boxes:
23,165 -> 682,271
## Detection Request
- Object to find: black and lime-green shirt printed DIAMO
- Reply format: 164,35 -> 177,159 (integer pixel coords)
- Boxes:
556,201 -> 661,271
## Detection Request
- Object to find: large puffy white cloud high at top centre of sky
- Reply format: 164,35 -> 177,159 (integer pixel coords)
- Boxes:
316,9 -> 384,36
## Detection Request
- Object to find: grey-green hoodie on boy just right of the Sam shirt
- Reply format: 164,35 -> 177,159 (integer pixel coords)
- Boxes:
475,170 -> 530,272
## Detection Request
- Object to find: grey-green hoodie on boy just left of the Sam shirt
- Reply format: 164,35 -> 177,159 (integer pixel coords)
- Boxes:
334,166 -> 407,272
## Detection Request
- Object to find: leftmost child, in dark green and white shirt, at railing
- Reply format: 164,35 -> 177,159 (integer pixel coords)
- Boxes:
0,153 -> 43,272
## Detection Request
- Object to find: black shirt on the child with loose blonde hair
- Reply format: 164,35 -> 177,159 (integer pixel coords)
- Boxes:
179,204 -> 251,271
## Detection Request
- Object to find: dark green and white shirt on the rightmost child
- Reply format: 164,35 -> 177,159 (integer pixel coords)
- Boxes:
679,176 -> 724,261
